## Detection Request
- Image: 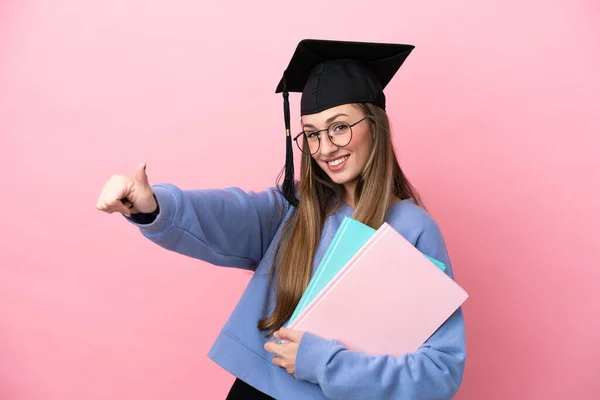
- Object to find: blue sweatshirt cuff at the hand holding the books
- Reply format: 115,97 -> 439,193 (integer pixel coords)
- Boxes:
295,332 -> 335,383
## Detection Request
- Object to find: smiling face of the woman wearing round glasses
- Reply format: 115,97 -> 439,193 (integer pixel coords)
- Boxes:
302,104 -> 373,195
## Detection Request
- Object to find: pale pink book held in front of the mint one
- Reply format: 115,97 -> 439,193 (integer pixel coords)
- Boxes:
289,223 -> 468,355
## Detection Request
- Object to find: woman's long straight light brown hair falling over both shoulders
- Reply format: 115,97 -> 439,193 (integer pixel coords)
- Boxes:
258,103 -> 423,336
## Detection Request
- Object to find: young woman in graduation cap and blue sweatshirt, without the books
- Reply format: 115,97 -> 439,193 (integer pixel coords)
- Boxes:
97,40 -> 466,400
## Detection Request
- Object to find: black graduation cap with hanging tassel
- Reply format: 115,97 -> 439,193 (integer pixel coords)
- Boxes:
275,39 -> 414,206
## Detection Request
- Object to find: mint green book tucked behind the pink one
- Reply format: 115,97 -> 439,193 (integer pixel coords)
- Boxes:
286,217 -> 446,326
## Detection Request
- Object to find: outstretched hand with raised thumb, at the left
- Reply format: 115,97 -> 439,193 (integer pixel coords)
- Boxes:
96,163 -> 158,217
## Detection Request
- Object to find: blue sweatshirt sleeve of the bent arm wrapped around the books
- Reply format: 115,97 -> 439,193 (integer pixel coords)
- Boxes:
296,219 -> 466,400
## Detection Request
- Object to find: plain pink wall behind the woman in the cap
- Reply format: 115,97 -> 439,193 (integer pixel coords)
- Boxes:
0,0 -> 600,400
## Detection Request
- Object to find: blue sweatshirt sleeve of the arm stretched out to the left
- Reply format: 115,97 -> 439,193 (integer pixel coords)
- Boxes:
125,183 -> 286,270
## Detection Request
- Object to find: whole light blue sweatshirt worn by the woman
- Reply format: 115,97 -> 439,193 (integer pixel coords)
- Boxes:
127,184 -> 466,400
